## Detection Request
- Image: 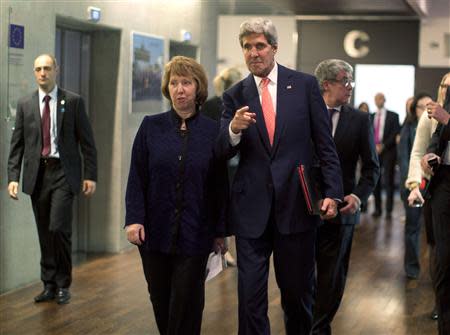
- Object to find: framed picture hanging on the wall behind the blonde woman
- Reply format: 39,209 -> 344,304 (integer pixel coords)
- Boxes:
130,32 -> 165,114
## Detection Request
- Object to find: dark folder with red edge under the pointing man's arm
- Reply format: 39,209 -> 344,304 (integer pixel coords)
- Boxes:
298,164 -> 323,215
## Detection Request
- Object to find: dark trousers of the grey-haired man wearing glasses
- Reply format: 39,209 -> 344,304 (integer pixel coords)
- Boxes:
312,213 -> 359,335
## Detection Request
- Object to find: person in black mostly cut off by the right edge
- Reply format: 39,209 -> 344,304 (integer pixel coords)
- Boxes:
421,90 -> 450,335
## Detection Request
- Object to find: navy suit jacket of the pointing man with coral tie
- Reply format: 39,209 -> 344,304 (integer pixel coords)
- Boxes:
216,65 -> 343,238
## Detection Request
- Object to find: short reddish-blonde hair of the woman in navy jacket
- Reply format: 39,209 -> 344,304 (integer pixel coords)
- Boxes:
161,56 -> 208,106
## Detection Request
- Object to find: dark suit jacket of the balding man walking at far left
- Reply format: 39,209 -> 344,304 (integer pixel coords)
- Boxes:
8,87 -> 97,194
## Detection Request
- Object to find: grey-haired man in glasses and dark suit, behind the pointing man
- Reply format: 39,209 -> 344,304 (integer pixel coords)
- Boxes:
312,59 -> 380,335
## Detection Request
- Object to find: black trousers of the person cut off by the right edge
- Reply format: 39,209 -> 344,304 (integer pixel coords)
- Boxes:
431,165 -> 450,335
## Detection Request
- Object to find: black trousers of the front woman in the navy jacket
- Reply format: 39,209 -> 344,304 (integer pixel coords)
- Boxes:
139,247 -> 208,335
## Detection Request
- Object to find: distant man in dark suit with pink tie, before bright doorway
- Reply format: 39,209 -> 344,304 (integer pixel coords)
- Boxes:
372,93 -> 400,219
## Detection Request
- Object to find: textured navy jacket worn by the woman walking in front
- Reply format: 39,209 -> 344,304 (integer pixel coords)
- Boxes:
125,110 -> 228,255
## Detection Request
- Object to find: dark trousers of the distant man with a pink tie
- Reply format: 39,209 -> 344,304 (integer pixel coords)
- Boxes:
373,152 -> 397,214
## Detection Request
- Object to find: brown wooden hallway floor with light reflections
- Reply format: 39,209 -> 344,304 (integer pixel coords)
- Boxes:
0,200 -> 437,335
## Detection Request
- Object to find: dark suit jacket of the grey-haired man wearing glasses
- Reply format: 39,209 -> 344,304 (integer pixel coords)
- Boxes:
334,105 -> 380,213
